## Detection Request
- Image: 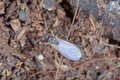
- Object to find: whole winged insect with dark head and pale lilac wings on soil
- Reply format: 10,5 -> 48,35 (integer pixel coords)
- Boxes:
45,34 -> 82,61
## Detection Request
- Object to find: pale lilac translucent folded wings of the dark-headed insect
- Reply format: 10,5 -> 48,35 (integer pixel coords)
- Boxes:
57,40 -> 81,61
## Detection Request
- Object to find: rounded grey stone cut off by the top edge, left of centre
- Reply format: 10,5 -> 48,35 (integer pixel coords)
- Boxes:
41,0 -> 55,11
